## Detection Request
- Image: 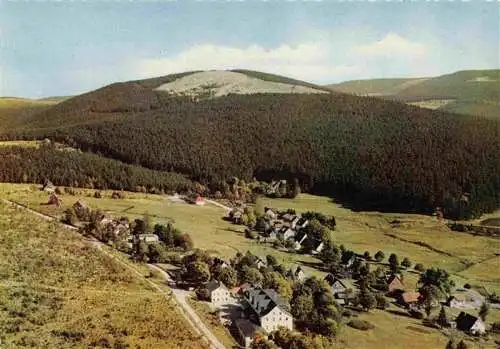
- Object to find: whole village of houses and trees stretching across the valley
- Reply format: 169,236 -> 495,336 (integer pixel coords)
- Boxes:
28,182 -> 500,348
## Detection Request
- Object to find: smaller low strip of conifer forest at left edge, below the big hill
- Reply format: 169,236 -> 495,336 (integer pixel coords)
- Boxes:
0,146 -> 194,193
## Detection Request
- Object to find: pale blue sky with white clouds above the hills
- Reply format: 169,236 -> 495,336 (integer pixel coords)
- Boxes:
0,0 -> 500,98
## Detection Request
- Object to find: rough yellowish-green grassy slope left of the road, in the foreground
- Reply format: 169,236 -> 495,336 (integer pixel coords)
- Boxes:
0,200 -> 207,349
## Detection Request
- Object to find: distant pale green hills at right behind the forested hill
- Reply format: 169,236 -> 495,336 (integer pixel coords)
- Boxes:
327,70 -> 500,117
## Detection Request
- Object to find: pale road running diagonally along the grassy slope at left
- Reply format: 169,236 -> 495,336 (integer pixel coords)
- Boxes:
1,199 -> 229,349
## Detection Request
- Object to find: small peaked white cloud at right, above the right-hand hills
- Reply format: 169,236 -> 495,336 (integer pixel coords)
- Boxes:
351,33 -> 428,57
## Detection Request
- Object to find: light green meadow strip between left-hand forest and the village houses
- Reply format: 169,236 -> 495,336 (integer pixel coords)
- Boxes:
0,184 -> 323,275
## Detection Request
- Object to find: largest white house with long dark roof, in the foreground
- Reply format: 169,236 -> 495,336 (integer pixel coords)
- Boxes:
244,288 -> 293,333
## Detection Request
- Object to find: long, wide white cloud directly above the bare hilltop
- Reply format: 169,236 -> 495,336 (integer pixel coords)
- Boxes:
135,43 -> 359,81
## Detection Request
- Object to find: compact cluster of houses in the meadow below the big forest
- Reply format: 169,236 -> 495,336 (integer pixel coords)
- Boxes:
229,207 -> 324,254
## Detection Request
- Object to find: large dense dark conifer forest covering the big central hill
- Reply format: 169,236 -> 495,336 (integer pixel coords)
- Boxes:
3,73 -> 500,218
